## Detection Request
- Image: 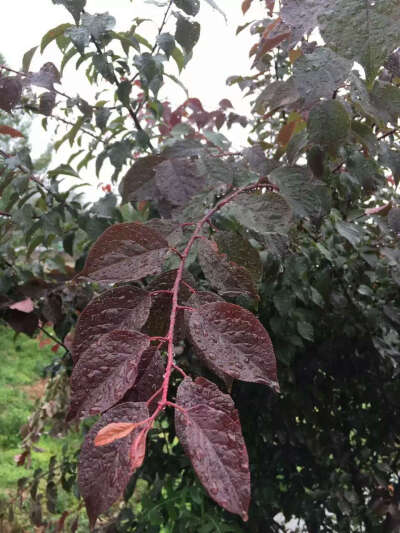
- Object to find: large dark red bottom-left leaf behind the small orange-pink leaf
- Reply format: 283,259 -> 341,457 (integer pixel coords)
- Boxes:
78,403 -> 149,528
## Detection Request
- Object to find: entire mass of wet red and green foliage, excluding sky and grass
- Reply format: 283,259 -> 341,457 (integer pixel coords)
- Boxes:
0,0 -> 400,533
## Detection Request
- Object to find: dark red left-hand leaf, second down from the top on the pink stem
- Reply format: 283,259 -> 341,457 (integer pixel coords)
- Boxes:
72,286 -> 151,362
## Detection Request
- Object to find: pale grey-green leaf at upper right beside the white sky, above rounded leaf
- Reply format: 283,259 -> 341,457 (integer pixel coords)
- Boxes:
293,47 -> 352,108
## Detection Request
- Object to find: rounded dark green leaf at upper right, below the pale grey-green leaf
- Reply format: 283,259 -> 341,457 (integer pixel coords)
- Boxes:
307,100 -> 350,148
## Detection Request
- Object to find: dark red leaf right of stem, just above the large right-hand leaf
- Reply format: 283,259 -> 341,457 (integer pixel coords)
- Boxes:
198,239 -> 258,299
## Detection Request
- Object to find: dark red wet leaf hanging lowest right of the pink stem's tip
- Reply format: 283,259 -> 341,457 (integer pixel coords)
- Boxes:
175,378 -> 250,521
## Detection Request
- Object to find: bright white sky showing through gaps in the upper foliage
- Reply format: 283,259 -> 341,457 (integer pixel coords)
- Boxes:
0,0 -> 266,189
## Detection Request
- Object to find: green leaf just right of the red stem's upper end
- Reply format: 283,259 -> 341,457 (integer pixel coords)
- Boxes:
270,167 -> 331,218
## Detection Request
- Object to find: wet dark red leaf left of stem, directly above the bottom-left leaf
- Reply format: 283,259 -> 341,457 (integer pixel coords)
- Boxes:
67,330 -> 150,420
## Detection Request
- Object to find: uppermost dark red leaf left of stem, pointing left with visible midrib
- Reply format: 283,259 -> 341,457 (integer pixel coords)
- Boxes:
78,222 -> 168,283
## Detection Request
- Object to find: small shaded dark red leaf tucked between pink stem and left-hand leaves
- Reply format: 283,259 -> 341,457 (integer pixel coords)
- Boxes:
123,346 -> 165,407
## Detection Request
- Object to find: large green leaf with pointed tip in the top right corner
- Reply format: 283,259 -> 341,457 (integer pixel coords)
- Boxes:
318,0 -> 400,82
